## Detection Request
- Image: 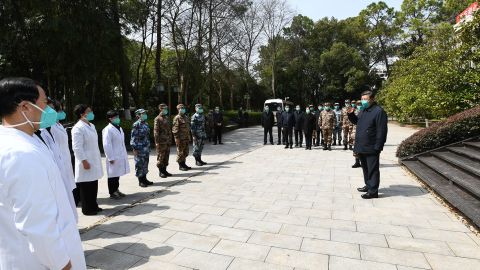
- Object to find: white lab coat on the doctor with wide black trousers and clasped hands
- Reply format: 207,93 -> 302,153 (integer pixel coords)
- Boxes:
72,120 -> 103,183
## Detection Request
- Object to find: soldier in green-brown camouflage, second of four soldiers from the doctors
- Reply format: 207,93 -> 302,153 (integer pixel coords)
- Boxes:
153,103 -> 172,178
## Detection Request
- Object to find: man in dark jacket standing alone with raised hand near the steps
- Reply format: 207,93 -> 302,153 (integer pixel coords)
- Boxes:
348,91 -> 388,199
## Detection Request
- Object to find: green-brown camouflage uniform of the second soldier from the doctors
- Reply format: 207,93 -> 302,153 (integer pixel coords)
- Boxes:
153,115 -> 172,168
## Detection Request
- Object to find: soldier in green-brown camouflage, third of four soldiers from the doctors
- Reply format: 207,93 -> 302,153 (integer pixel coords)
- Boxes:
172,104 -> 191,171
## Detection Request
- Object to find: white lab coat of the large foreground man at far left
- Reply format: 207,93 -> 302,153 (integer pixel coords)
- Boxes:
0,126 -> 86,270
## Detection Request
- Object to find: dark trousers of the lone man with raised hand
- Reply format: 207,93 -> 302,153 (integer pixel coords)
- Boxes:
358,154 -> 380,194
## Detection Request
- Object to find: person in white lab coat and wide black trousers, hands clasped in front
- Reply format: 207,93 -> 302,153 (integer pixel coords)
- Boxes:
72,104 -> 103,216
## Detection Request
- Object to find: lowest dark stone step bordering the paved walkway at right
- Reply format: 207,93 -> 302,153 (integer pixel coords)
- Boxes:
402,161 -> 480,226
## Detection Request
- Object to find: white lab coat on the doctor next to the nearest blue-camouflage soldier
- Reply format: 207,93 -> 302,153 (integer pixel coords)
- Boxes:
102,124 -> 130,178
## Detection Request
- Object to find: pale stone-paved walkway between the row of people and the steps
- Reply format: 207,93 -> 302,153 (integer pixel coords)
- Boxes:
80,125 -> 480,270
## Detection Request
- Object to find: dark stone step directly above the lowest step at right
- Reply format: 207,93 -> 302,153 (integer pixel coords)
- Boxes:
418,156 -> 480,199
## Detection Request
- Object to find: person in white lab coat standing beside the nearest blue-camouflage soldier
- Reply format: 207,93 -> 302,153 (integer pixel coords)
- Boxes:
102,110 -> 130,200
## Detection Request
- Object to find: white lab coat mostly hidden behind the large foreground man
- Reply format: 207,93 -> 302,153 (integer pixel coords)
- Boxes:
41,123 -> 78,221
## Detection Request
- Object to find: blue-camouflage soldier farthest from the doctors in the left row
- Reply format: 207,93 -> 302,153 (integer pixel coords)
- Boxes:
190,104 -> 207,166
